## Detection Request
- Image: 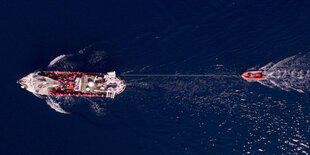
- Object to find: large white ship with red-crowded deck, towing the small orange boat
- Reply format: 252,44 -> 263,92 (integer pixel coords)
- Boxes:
18,71 -> 126,98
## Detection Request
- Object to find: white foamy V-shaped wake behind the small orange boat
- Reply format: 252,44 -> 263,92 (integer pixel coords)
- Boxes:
258,53 -> 310,93
